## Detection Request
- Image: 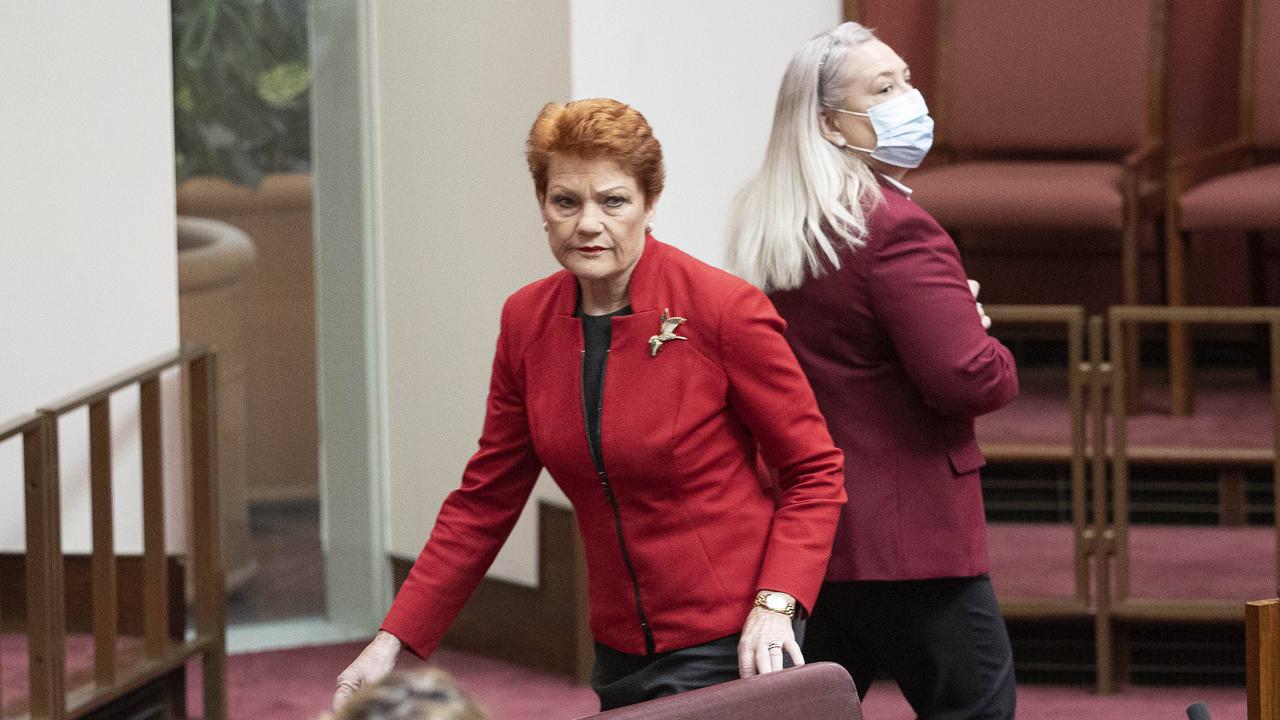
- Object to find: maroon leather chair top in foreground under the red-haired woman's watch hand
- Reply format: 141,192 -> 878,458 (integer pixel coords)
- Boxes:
581,662 -> 863,720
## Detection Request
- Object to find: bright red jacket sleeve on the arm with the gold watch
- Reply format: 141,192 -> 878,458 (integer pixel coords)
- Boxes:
721,284 -> 845,609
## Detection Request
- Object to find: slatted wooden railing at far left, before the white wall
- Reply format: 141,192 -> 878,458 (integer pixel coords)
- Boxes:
0,348 -> 227,720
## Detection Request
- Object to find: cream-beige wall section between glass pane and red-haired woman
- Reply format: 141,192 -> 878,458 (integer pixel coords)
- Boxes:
375,0 -> 570,584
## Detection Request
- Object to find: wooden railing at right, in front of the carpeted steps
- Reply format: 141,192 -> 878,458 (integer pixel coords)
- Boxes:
967,301 -> 1280,691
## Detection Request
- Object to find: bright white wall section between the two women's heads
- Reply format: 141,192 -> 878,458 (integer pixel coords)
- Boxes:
572,0 -> 842,266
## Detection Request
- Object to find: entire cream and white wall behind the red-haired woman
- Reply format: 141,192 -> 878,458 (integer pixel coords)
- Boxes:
374,0 -> 840,584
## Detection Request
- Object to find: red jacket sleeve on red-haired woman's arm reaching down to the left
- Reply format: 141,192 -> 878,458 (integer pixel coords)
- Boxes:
381,297 -> 541,659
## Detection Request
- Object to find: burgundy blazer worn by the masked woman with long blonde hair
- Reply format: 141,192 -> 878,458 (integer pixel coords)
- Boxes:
757,186 -> 1018,580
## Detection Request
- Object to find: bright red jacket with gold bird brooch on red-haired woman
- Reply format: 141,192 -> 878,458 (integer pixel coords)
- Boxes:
383,237 -> 845,656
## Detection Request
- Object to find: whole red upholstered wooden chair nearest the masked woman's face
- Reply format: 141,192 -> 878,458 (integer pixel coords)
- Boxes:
906,0 -> 1165,311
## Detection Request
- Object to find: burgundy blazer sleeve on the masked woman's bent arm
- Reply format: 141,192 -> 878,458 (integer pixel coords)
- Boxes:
867,208 -> 1018,418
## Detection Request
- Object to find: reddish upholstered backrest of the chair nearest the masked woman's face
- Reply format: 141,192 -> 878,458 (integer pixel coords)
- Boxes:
936,0 -> 1165,152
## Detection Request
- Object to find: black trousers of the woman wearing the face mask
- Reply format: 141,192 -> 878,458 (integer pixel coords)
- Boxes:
804,575 -> 1016,720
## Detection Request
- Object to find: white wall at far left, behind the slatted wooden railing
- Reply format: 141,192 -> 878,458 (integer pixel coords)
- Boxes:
0,0 -> 180,552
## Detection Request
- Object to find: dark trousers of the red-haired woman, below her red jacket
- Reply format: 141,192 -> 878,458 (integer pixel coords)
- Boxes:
591,620 -> 805,711
